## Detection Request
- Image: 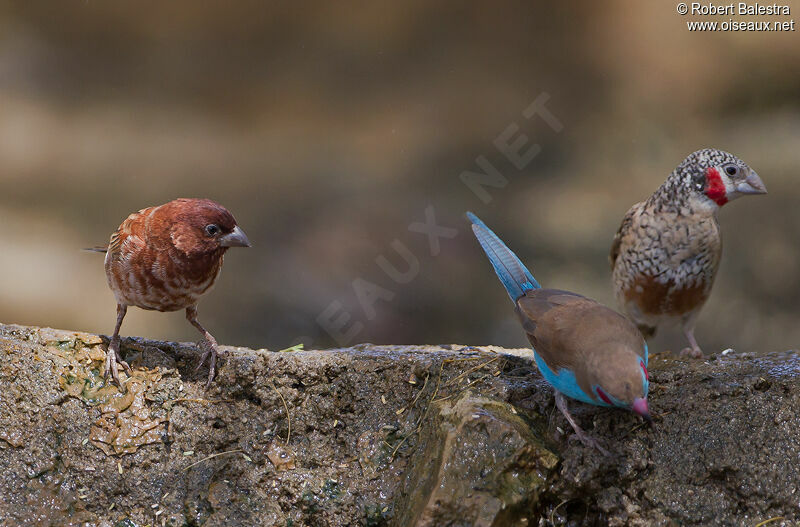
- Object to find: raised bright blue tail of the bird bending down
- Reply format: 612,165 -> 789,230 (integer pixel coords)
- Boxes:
467,212 -> 541,302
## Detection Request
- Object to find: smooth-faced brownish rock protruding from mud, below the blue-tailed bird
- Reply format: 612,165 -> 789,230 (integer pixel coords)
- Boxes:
396,392 -> 558,527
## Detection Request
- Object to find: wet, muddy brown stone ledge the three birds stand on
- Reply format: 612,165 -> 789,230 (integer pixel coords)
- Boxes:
0,325 -> 800,527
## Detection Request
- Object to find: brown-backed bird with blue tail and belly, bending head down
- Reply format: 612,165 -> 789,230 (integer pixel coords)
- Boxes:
467,212 -> 650,452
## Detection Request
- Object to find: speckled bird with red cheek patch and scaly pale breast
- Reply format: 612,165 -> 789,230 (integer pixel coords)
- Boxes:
610,148 -> 767,358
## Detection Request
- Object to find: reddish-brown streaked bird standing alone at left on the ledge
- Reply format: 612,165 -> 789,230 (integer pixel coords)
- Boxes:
98,198 -> 250,388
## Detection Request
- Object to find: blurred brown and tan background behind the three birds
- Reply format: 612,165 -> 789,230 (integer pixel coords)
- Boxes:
0,0 -> 800,352
